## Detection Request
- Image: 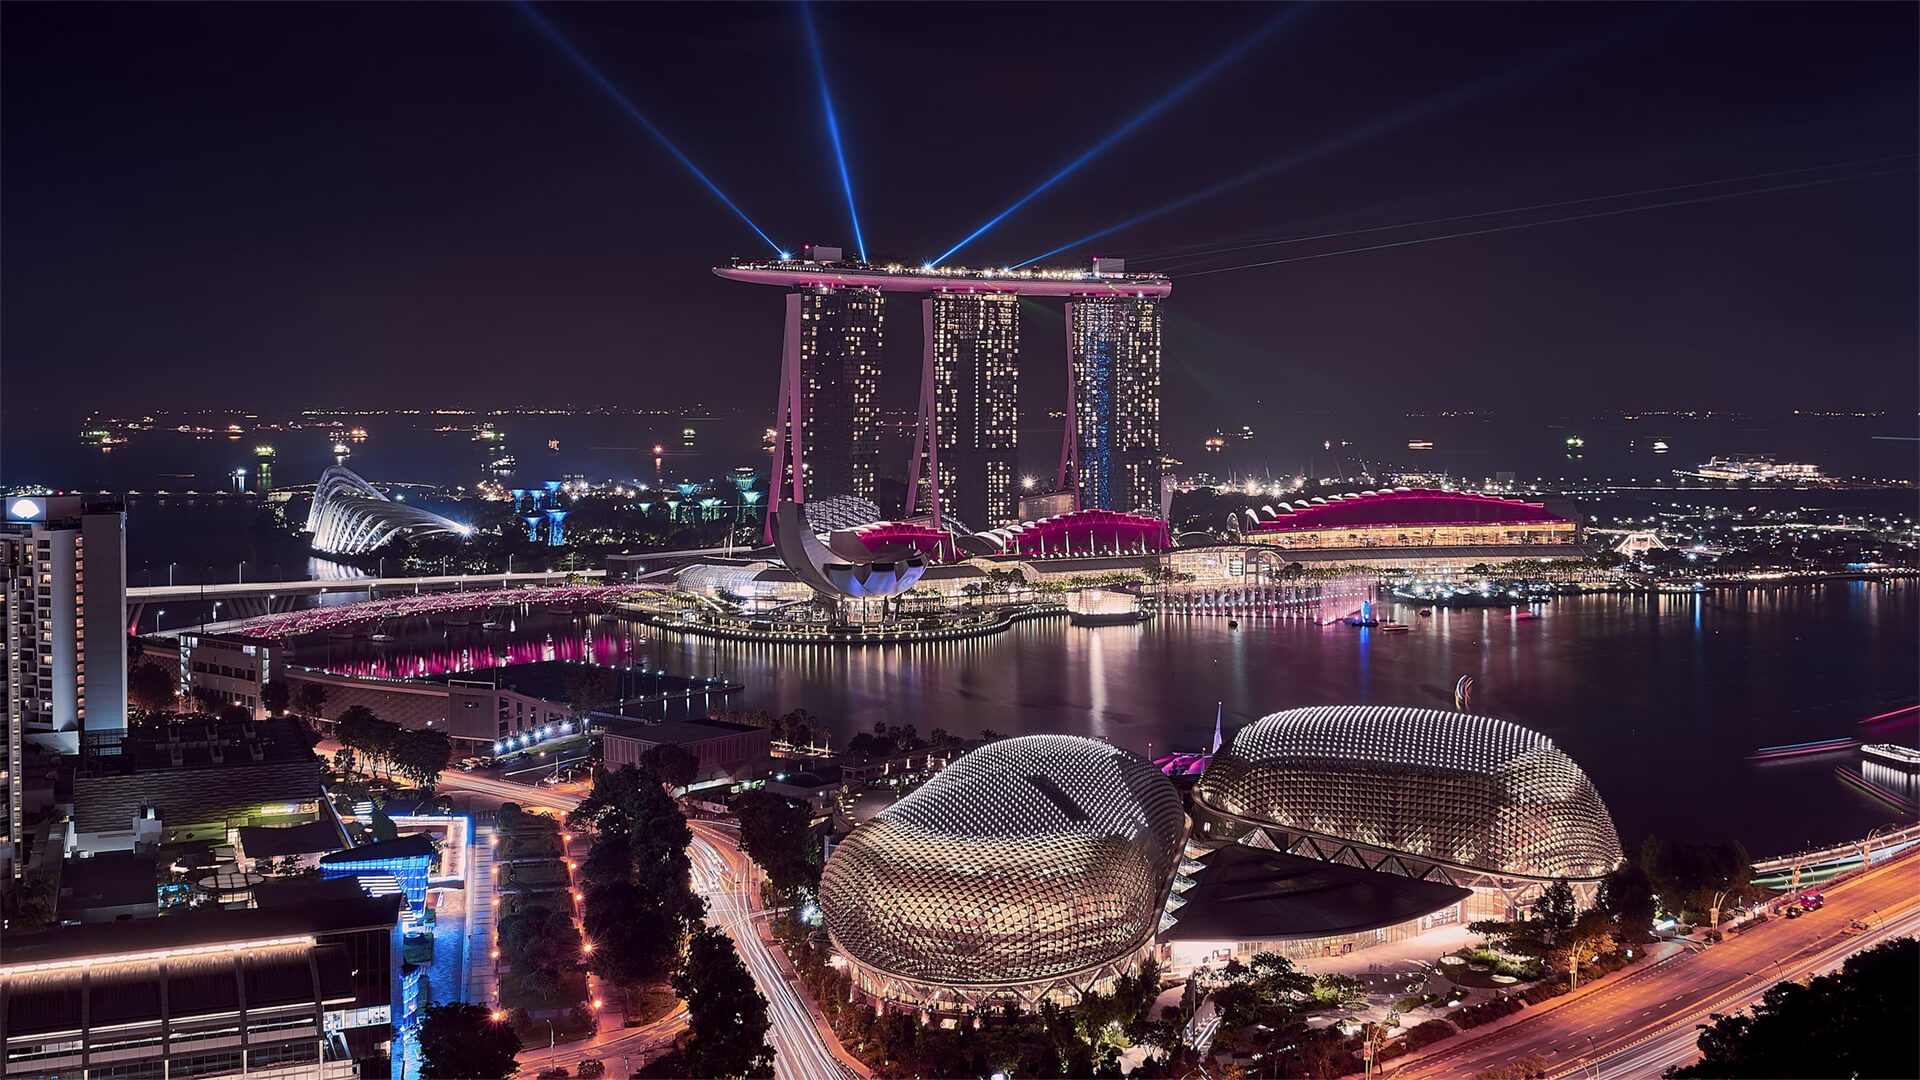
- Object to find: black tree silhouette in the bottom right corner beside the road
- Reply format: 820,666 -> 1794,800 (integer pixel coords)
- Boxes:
1667,938 -> 1920,1080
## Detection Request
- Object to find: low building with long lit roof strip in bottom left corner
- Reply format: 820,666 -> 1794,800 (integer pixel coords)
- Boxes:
0,886 -> 405,1080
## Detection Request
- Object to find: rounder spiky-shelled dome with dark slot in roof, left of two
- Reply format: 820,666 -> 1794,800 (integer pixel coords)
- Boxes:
820,734 -> 1187,1009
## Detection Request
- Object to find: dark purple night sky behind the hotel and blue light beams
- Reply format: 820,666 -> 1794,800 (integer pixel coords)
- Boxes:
0,4 -> 1920,442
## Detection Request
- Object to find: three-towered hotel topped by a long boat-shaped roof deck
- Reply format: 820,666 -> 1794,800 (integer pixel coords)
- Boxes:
714,246 -> 1173,530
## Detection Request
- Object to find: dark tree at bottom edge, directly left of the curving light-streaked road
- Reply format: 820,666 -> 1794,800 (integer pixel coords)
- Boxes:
674,924 -> 774,1078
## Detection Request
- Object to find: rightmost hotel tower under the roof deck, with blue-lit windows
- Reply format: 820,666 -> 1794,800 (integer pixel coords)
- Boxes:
1068,296 -> 1160,515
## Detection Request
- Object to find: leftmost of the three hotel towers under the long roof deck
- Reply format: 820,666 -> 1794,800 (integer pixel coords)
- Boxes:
774,284 -> 885,502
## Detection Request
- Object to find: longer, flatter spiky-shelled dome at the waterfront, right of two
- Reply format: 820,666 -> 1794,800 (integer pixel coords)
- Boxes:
1194,705 -> 1620,884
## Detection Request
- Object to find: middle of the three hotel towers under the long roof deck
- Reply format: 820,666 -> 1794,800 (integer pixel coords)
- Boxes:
908,292 -> 1020,528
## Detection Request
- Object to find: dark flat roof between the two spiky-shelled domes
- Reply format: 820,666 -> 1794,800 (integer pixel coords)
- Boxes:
1160,844 -> 1473,942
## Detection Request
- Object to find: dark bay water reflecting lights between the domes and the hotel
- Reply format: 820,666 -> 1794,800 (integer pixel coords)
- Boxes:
303,582 -> 1920,857
